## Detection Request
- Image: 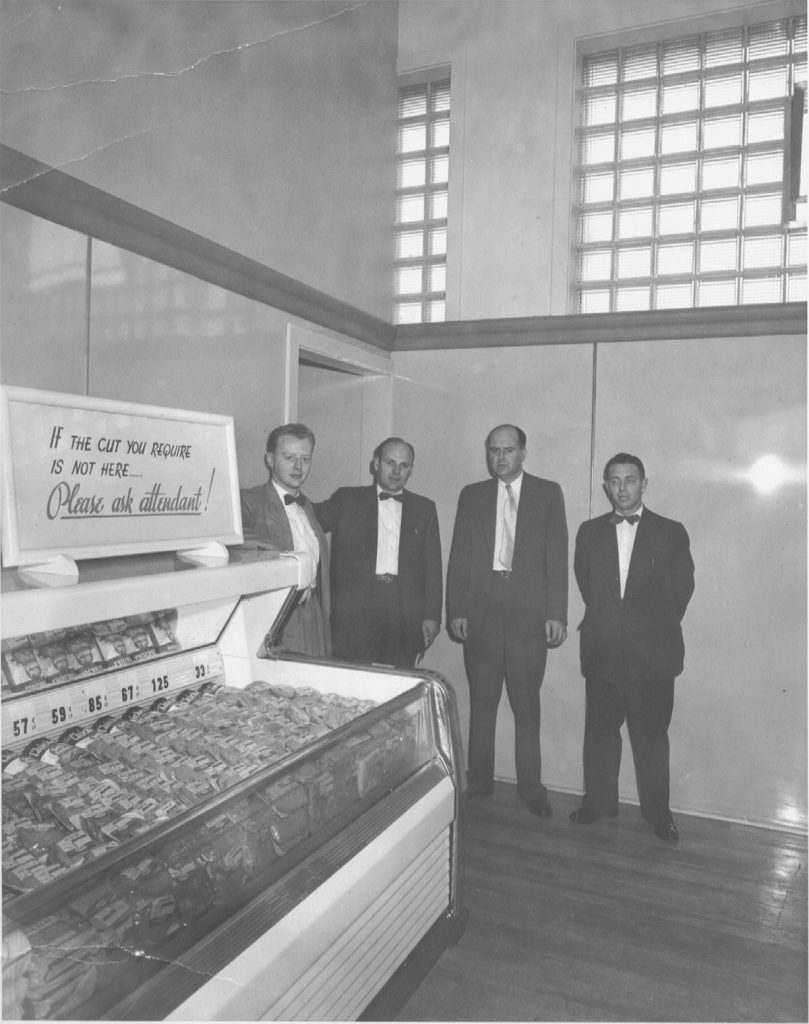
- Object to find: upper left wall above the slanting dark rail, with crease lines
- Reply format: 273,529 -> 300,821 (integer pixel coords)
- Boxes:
0,0 -> 396,317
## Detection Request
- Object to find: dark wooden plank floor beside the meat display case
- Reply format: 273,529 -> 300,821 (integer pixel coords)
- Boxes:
396,783 -> 808,1022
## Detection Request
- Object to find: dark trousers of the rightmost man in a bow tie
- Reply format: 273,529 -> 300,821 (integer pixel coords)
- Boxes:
584,670 -> 674,825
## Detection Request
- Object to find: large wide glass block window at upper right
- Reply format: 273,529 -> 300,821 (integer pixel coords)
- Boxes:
576,17 -> 807,312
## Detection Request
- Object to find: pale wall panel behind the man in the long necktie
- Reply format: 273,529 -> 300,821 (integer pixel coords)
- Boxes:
393,345 -> 592,806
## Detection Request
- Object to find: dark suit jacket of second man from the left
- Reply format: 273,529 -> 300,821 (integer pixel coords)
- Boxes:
314,484 -> 443,652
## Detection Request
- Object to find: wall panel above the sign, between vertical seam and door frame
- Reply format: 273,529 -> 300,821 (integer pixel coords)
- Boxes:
90,243 -> 287,486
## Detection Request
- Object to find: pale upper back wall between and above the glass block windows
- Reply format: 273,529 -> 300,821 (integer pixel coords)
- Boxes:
398,0 -> 806,319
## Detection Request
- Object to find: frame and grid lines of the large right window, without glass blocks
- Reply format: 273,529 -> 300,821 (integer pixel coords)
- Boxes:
568,3 -> 806,315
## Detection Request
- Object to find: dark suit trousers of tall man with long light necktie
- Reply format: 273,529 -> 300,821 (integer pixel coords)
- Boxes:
464,577 -> 548,801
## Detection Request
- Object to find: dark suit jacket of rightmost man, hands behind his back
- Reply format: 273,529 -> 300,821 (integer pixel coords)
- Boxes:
573,507 -> 694,680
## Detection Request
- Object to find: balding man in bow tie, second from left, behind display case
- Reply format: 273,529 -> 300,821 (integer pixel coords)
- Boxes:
314,437 -> 443,668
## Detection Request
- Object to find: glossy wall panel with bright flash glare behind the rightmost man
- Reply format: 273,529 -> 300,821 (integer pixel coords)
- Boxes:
596,338 -> 807,826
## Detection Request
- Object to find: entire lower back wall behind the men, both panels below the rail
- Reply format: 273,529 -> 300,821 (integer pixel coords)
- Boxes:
394,338 -> 806,827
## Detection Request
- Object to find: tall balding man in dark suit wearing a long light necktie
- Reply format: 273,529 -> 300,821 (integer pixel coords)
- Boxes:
446,424 -> 567,817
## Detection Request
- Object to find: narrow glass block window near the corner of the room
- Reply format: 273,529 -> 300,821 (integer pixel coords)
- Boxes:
393,79 -> 450,324
